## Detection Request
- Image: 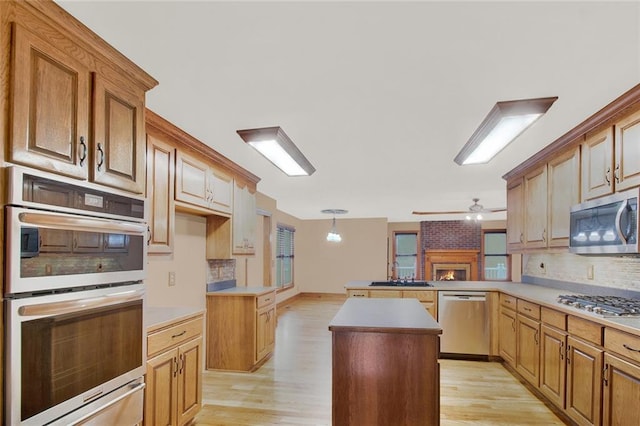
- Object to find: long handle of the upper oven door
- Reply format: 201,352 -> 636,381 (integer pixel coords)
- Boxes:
18,211 -> 147,235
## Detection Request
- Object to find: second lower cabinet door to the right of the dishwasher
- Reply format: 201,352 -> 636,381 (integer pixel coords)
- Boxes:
516,315 -> 540,387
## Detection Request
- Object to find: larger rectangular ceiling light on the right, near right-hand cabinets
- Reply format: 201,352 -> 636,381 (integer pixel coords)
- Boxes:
454,96 -> 558,166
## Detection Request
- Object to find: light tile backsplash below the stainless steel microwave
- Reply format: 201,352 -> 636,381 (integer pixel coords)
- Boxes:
522,253 -> 640,291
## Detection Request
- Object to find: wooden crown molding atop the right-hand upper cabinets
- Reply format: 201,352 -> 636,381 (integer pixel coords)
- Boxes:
502,84 -> 640,181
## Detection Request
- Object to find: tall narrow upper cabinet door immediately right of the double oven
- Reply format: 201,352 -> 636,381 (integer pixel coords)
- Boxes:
147,135 -> 175,253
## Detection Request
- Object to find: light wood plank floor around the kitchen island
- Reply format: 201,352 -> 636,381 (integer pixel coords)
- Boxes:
195,298 -> 564,426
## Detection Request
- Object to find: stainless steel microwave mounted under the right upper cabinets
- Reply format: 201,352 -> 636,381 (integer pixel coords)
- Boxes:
569,188 -> 640,255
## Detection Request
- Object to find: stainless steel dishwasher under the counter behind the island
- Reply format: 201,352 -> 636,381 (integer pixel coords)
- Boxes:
438,291 -> 490,355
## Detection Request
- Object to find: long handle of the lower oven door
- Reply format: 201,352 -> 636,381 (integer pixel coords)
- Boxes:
18,290 -> 144,317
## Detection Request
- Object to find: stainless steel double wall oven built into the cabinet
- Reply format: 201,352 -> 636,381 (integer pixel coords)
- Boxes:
4,167 -> 147,425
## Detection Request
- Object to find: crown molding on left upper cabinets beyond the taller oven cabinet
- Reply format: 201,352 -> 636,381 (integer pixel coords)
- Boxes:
145,108 -> 260,185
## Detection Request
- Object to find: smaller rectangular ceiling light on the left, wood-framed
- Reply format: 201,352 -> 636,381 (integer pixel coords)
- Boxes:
237,126 -> 316,176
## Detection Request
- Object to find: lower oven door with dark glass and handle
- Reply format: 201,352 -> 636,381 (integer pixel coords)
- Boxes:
8,284 -> 144,424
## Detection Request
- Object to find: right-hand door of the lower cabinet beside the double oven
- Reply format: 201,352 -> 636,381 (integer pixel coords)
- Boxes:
177,339 -> 202,426
